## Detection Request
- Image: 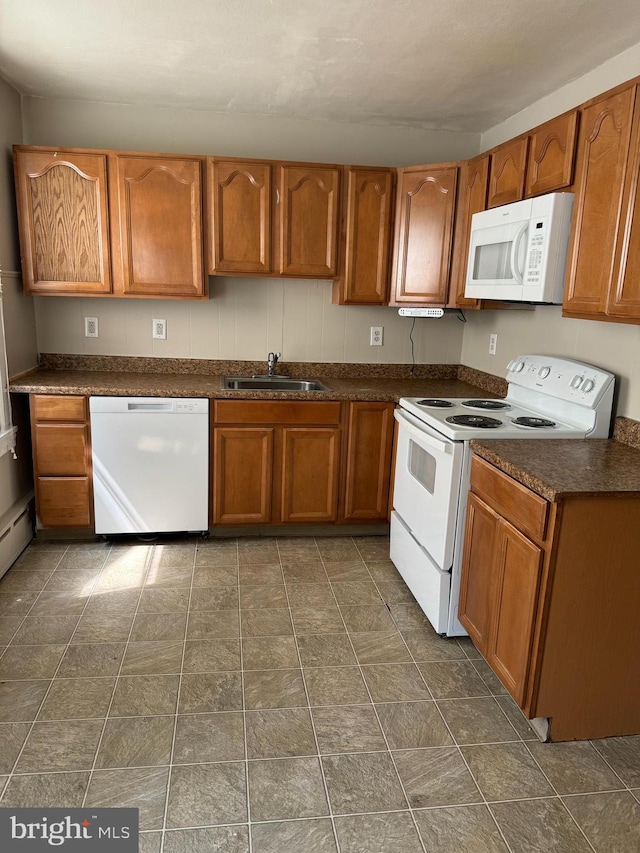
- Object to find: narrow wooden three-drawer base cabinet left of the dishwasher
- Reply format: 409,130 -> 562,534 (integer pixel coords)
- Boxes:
31,394 -> 93,528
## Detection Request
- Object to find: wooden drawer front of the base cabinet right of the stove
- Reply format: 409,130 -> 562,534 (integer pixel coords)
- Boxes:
471,456 -> 549,542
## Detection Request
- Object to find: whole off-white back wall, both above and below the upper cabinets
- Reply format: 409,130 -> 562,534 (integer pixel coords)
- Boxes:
23,98 -> 470,363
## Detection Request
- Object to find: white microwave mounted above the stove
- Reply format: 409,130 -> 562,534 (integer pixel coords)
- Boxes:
464,193 -> 573,305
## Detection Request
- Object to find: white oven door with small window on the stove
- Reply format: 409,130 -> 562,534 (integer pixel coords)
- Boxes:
393,409 -> 464,572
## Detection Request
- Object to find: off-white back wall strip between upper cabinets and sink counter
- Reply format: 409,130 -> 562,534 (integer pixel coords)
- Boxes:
35,277 -> 464,364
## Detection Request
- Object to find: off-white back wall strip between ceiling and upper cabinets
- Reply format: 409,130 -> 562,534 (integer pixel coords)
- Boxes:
23,97 -> 480,166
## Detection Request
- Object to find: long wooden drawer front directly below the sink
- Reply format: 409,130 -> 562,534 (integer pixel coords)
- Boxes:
213,400 -> 341,425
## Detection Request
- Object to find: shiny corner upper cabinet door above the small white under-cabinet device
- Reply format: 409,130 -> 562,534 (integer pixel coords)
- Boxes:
393,166 -> 458,305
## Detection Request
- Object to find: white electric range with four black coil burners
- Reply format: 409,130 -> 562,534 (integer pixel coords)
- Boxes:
390,355 -> 615,636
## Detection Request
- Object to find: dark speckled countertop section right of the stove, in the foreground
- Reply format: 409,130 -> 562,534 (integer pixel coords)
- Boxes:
471,438 -> 640,501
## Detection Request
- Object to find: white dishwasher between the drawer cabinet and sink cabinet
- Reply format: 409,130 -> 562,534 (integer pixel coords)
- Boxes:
89,397 -> 209,535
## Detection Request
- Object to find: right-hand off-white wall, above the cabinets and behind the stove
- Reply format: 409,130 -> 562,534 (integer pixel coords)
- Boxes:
462,45 -> 640,420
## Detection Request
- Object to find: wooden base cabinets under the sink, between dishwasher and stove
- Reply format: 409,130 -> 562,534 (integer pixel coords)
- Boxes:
211,400 -> 394,525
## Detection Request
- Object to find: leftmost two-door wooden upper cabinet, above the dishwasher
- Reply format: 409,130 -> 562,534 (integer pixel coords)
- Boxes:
14,145 -> 206,298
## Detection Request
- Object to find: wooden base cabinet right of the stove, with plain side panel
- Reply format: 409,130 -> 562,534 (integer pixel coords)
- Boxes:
459,457 -> 640,741
